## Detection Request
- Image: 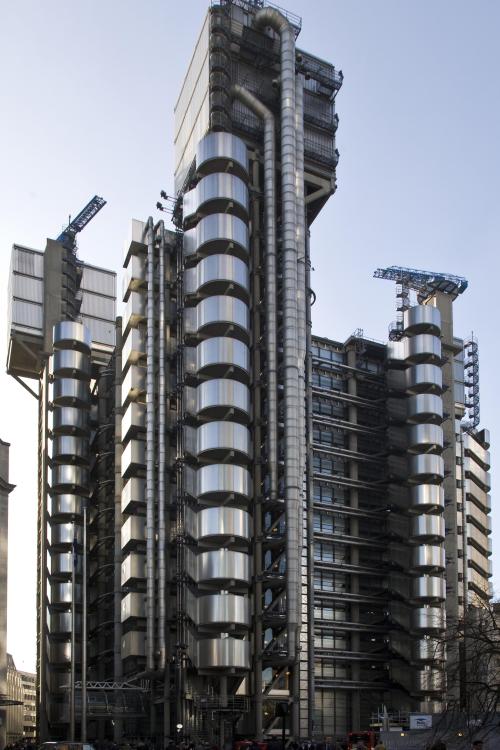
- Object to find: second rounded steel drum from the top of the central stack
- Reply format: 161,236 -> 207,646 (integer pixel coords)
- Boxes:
182,172 -> 249,221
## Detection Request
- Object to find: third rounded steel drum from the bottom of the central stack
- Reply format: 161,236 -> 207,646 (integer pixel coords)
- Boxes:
186,549 -> 252,585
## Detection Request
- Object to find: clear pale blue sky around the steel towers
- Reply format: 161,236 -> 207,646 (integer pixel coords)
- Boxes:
0,0 -> 500,669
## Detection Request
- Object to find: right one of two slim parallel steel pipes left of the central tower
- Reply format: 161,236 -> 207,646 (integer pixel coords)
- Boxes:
159,221 -> 167,669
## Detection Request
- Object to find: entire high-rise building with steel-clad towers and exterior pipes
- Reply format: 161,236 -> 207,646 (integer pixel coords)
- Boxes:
8,0 -> 491,746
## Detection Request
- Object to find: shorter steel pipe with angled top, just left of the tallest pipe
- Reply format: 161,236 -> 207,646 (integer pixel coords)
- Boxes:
231,85 -> 278,500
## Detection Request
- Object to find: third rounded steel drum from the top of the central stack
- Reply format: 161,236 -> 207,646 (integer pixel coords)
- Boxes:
183,214 -> 248,260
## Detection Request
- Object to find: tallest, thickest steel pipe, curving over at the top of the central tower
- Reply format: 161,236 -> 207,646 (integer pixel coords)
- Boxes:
254,2 -> 302,672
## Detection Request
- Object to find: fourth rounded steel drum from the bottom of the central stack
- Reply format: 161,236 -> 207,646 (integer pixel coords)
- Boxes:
186,506 -> 252,542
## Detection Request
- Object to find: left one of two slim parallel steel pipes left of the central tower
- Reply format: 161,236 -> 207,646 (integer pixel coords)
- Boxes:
146,216 -> 155,670
